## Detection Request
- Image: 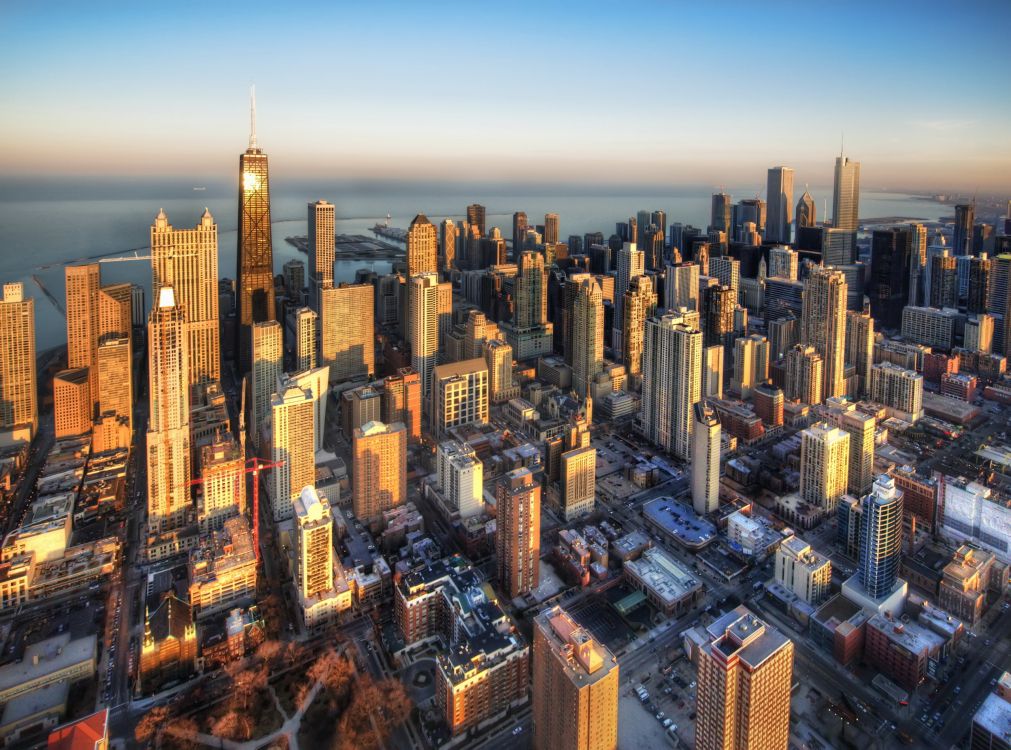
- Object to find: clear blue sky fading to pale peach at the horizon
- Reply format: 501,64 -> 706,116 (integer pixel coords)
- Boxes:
0,0 -> 1011,190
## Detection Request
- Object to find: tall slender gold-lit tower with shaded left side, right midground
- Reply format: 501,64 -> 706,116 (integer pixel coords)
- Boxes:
801,266 -> 846,398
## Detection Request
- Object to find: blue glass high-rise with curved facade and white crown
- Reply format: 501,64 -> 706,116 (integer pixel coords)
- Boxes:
856,474 -> 902,599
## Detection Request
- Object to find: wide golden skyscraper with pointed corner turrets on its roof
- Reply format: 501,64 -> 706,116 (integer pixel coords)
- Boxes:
151,208 -> 220,394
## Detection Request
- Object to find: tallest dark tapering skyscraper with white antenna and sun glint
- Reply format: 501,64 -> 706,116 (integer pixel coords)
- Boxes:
238,99 -> 277,373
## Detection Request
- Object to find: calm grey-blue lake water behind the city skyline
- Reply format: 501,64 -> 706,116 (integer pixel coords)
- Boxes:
0,178 -> 951,351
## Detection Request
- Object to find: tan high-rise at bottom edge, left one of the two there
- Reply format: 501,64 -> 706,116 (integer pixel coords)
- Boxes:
532,604 -> 621,750
